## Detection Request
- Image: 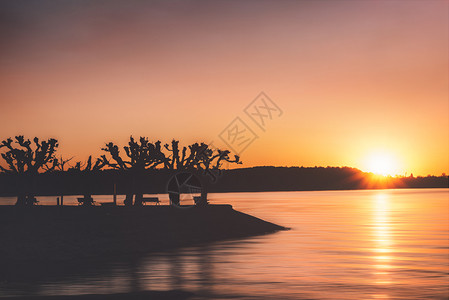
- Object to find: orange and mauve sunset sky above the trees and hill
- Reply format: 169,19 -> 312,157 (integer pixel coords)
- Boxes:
0,0 -> 449,175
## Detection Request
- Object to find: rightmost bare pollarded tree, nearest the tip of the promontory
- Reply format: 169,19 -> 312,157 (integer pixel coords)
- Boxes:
164,140 -> 242,205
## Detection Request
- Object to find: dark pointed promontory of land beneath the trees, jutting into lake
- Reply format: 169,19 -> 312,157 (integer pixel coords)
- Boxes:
0,205 -> 285,261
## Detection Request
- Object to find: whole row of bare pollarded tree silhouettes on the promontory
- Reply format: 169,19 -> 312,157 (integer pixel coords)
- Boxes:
0,136 -> 241,206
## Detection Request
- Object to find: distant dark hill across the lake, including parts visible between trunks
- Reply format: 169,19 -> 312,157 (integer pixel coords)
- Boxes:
0,166 -> 449,196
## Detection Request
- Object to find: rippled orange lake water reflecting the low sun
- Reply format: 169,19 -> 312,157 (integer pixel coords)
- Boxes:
0,189 -> 449,300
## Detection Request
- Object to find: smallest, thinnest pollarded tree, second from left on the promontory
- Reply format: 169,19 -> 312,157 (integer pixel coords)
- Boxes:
66,156 -> 105,206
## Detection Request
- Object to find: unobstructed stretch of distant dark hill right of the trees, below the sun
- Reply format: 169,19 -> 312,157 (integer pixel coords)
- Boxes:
211,167 -> 449,192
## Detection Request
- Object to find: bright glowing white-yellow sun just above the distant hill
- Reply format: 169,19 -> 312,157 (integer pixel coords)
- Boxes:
364,152 -> 399,176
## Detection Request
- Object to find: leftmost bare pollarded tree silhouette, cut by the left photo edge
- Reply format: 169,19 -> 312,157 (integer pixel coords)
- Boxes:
0,135 -> 58,205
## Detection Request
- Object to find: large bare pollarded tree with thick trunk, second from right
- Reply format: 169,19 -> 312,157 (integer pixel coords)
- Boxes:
101,136 -> 167,206
